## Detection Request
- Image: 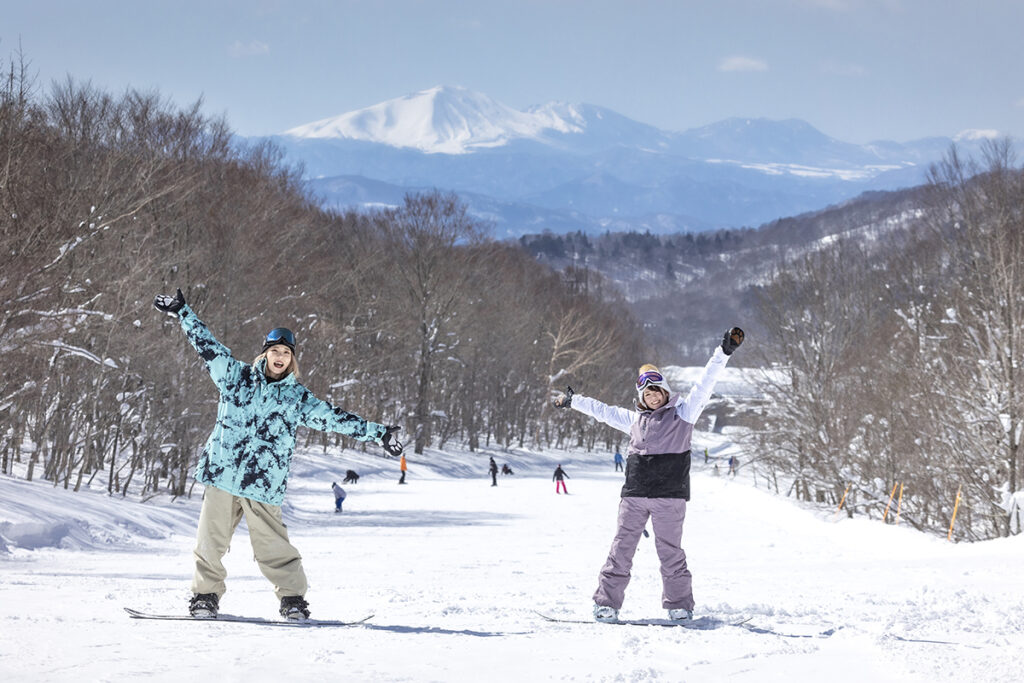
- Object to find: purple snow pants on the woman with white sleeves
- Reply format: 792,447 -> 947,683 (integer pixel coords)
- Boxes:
594,498 -> 693,609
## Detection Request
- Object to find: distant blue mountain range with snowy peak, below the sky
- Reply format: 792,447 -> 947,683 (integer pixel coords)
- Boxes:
256,86 -> 1007,238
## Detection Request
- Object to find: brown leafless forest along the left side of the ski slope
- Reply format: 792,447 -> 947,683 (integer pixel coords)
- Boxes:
0,63 -> 643,496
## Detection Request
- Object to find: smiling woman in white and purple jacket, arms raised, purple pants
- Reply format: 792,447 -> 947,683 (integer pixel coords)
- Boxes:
554,328 -> 743,622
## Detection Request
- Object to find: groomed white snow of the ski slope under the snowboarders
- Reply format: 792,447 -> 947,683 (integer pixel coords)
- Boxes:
0,432 -> 1024,683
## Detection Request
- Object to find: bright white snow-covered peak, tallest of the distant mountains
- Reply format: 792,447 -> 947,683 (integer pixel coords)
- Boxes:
285,86 -> 581,155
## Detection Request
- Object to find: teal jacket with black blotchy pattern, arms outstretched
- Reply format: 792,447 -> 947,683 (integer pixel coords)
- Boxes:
178,306 -> 384,506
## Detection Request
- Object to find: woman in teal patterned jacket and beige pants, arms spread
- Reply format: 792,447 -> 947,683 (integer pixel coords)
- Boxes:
153,290 -> 401,620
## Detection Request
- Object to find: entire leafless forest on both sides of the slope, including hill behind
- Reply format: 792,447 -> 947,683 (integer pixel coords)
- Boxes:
0,57 -> 1024,540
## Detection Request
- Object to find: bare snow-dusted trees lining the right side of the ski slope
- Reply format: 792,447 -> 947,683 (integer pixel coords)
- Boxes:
753,140 -> 1024,539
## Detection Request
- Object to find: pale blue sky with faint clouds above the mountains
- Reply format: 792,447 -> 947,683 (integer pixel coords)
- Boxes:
0,0 -> 1024,142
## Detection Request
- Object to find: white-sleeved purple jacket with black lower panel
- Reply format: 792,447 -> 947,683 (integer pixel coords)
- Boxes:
570,347 -> 729,501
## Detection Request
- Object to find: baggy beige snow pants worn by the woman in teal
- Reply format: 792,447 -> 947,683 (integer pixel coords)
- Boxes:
191,486 -> 307,599
